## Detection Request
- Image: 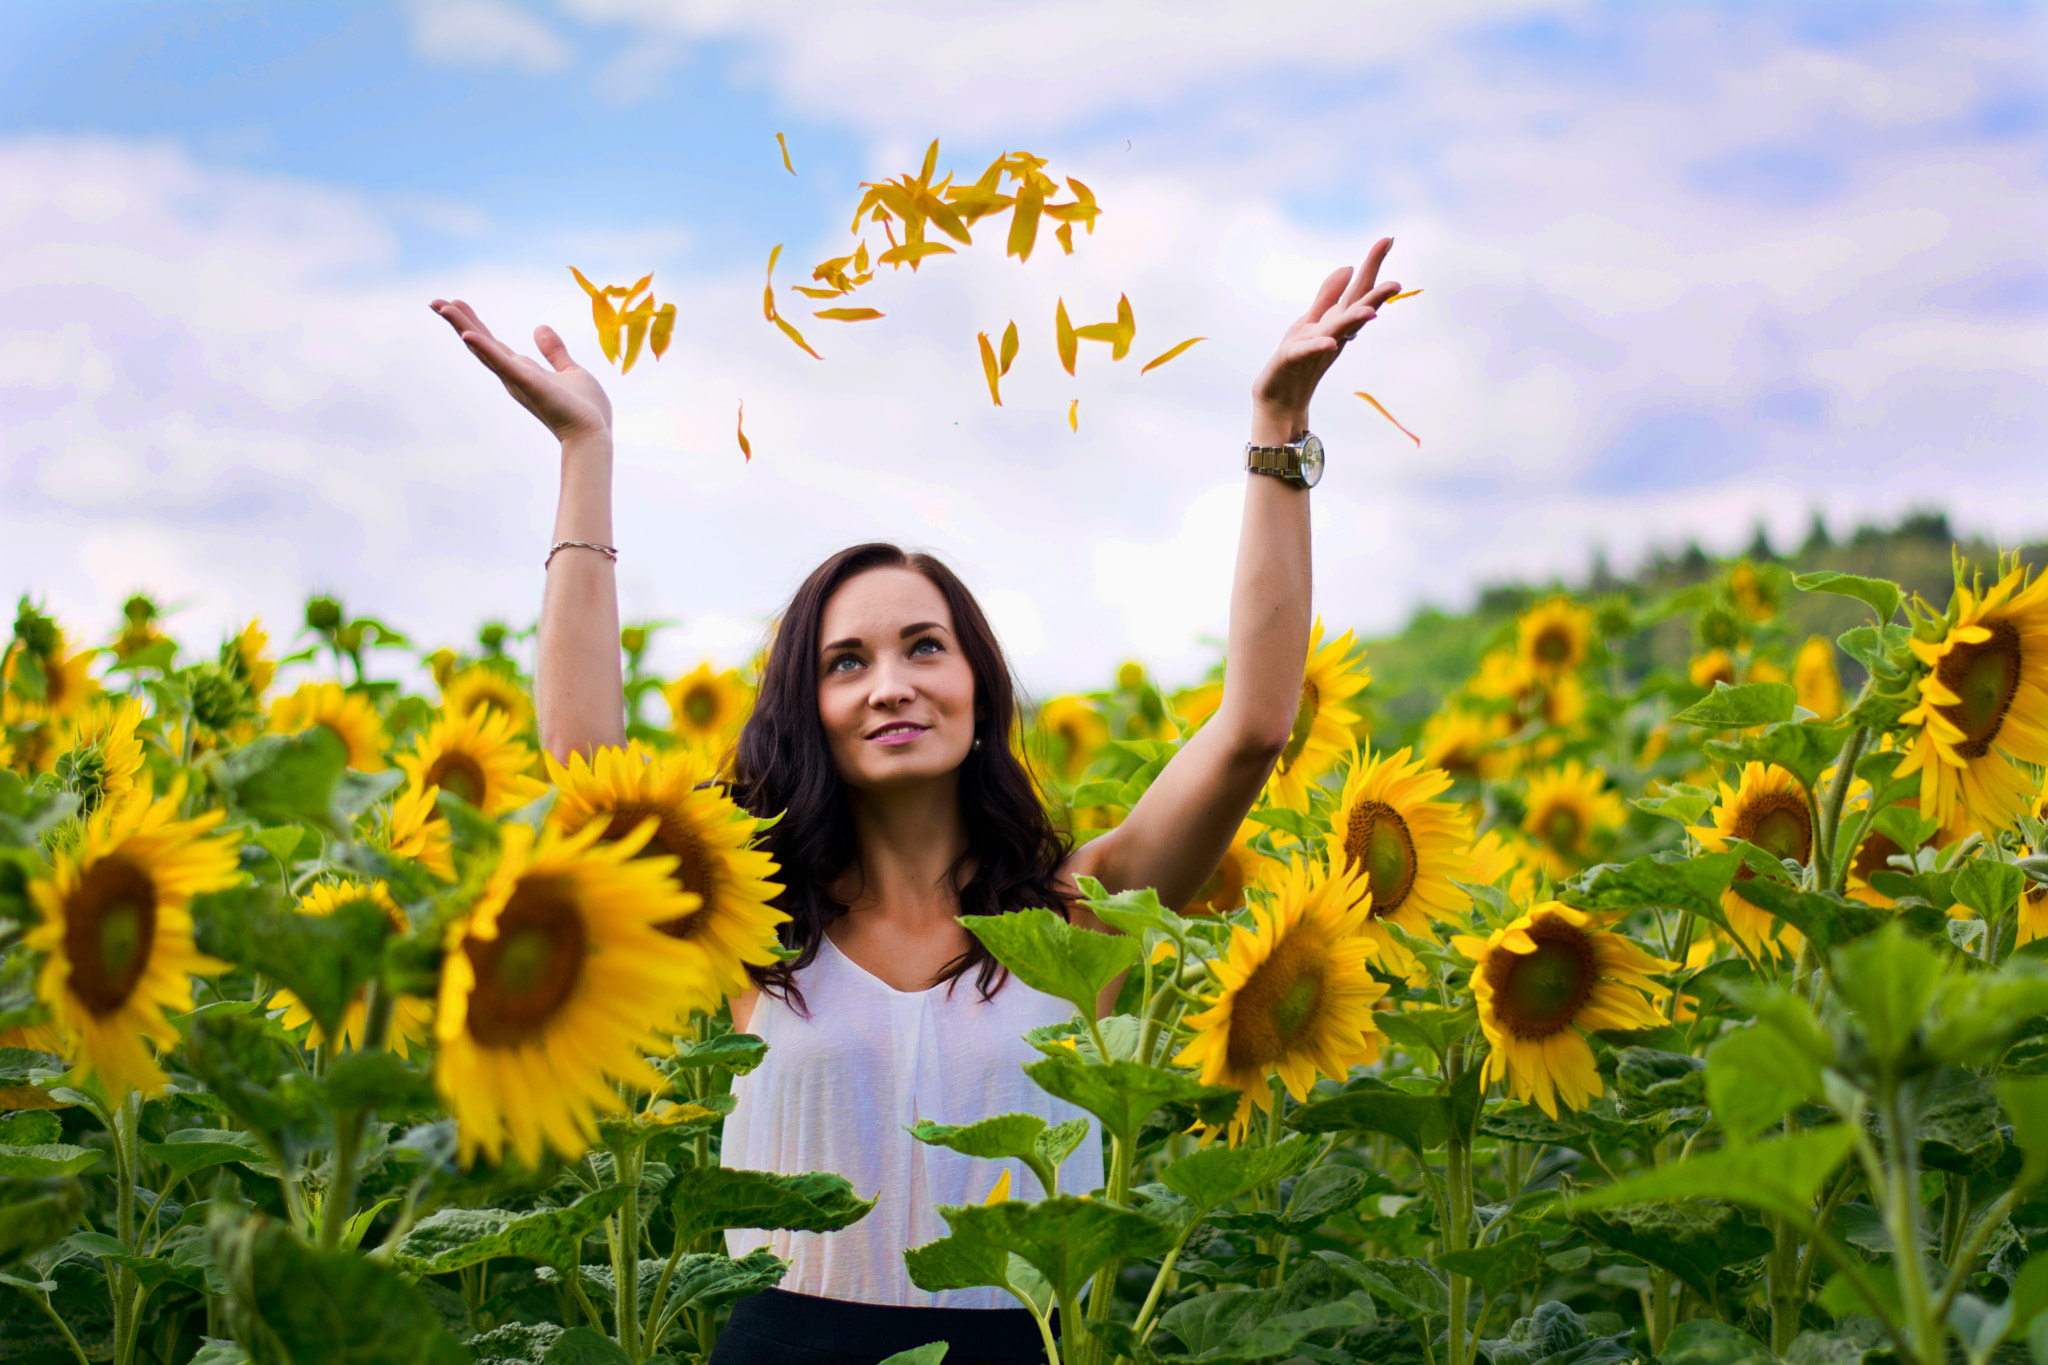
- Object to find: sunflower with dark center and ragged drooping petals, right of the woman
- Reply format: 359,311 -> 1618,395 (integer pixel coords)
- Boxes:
1452,900 -> 1675,1119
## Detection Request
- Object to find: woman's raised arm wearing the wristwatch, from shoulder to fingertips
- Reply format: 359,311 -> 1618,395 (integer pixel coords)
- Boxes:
1067,237 -> 1401,907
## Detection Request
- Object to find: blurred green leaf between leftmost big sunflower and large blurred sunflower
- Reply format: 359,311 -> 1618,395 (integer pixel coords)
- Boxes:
193,879 -> 391,1038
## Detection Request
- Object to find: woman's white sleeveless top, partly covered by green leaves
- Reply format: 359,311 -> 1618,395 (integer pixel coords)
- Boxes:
721,935 -> 1102,1308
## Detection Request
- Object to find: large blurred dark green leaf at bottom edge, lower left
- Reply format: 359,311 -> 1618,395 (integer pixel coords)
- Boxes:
211,1218 -> 469,1365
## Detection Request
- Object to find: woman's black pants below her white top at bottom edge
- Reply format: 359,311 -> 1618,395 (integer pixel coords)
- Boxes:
709,1289 -> 1059,1365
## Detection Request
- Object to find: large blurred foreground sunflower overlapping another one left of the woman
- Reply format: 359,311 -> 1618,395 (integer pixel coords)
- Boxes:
434,821 -> 702,1166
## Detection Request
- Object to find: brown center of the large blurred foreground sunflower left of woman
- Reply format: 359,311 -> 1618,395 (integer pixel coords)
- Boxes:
463,876 -> 590,1048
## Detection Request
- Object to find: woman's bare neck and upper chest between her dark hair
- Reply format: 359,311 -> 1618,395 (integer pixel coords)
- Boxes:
846,774 -> 967,925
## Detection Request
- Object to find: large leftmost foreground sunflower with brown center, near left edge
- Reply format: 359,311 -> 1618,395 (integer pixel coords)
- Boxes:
25,786 -> 240,1095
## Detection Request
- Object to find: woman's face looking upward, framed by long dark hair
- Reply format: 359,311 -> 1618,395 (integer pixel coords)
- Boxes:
817,569 -> 975,790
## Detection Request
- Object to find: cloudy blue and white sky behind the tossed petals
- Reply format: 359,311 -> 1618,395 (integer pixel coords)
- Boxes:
0,0 -> 2048,686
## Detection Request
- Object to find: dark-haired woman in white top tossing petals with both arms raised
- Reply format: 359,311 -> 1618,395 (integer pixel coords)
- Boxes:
432,239 -> 1401,1365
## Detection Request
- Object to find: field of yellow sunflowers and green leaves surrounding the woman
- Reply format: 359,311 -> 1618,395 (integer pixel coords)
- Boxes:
0,557 -> 2048,1365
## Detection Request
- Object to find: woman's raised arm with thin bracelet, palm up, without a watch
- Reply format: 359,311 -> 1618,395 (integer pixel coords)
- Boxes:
430,299 -> 627,759
